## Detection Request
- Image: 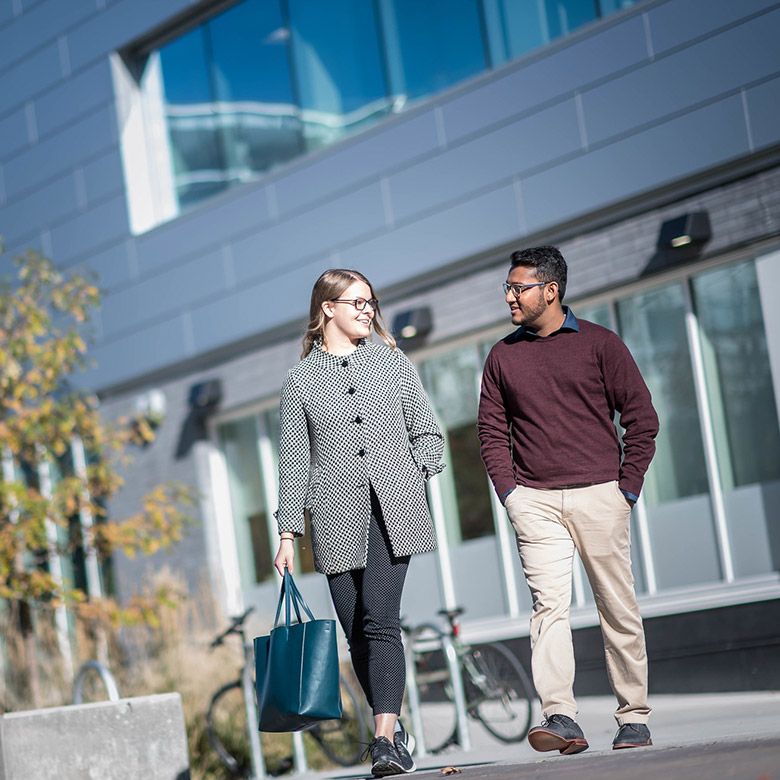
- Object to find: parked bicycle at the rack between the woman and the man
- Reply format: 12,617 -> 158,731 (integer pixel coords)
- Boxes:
402,608 -> 535,753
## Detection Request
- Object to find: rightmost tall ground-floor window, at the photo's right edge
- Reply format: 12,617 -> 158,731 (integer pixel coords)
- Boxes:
692,261 -> 780,577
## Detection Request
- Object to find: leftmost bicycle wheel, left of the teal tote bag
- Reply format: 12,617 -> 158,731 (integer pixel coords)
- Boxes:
206,680 -> 252,777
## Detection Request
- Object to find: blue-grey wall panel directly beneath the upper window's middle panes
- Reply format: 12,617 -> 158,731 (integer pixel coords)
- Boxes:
275,110 -> 438,216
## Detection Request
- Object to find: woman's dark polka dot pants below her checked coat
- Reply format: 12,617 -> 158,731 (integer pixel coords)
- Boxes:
328,489 -> 409,715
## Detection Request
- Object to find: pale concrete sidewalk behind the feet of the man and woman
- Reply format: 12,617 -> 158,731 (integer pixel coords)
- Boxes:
299,691 -> 780,780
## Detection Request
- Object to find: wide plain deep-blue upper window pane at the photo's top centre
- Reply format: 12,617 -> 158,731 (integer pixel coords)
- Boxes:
381,0 -> 488,100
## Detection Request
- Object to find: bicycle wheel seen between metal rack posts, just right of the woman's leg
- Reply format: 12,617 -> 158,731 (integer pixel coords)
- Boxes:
415,651 -> 457,753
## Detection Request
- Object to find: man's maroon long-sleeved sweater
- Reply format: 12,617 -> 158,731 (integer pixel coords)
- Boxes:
477,311 -> 658,498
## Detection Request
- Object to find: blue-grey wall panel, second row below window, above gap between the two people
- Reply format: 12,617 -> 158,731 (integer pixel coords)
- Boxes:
388,100 -> 581,221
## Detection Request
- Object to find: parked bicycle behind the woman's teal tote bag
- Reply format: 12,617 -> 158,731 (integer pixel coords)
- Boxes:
206,607 -> 366,778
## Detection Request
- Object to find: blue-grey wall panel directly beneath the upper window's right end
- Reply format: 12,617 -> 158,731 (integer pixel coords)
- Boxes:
442,16 -> 648,141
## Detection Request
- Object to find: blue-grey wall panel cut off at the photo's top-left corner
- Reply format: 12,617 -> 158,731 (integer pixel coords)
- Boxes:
0,0 -> 97,71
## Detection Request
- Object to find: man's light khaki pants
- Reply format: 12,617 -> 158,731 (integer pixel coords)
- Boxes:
506,482 -> 650,725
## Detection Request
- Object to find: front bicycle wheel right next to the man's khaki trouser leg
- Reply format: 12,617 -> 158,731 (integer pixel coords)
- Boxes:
464,644 -> 534,742
